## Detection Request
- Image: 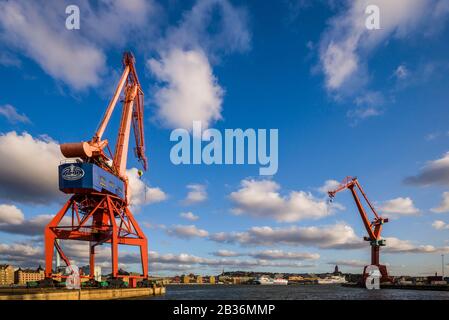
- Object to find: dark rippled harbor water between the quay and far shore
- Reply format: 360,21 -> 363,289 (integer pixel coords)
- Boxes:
142,285 -> 449,300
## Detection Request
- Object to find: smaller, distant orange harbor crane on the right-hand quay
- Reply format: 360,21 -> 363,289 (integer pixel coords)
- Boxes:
328,177 -> 391,282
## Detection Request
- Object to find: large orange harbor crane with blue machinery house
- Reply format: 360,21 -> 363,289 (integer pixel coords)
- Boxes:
45,52 -> 148,287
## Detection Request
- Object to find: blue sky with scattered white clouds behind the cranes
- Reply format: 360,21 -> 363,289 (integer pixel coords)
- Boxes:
0,0 -> 449,274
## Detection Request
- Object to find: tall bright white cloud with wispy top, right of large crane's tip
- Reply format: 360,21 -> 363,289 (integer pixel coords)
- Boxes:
147,0 -> 250,129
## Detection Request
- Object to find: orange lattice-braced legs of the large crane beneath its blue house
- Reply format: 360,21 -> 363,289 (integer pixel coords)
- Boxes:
45,193 -> 148,285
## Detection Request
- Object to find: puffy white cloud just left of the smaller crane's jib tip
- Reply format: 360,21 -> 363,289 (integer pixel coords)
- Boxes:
230,180 -> 341,222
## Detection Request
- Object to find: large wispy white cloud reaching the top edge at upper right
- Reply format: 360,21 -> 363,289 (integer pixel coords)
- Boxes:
320,0 -> 443,91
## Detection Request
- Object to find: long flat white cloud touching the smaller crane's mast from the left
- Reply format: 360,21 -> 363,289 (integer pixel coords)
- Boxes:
210,223 -> 367,249
